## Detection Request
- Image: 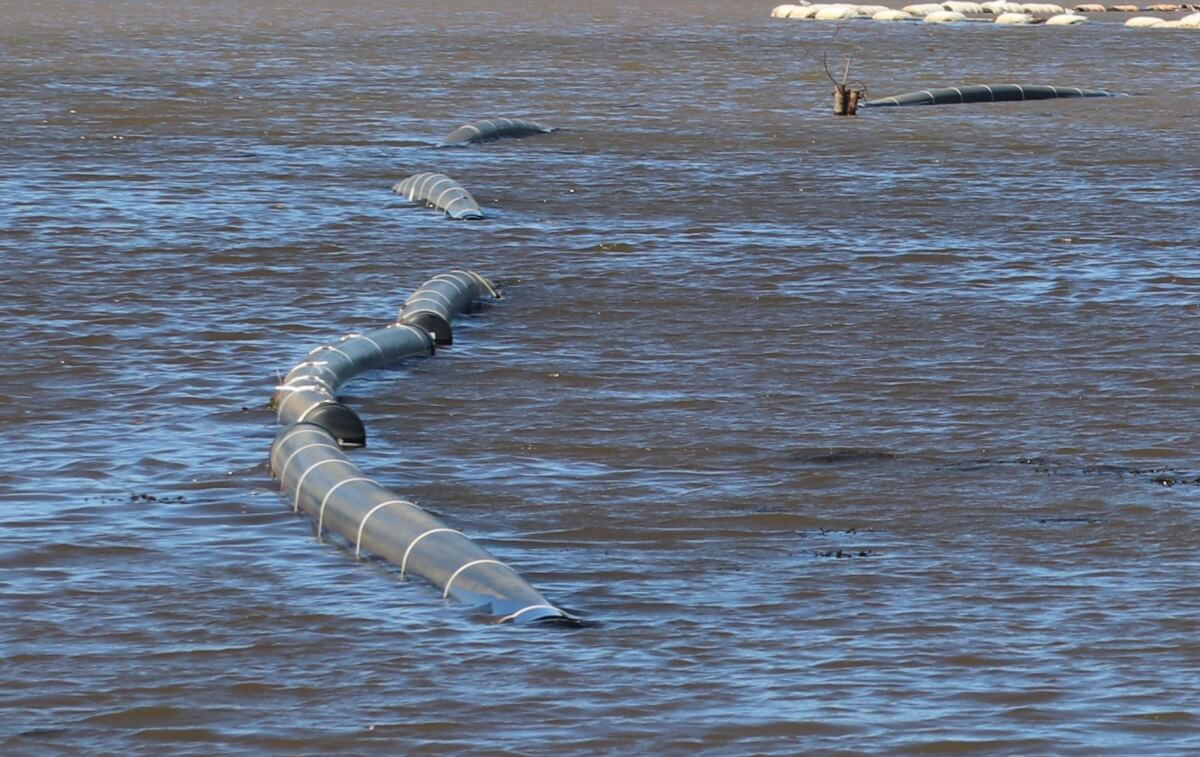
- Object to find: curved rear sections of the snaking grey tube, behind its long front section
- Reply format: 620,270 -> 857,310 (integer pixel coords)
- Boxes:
271,270 -> 496,447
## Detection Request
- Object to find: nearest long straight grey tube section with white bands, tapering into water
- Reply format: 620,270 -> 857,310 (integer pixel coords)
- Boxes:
271,423 -> 580,625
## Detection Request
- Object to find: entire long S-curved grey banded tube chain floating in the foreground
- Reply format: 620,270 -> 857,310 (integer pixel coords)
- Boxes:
270,270 -> 581,625
